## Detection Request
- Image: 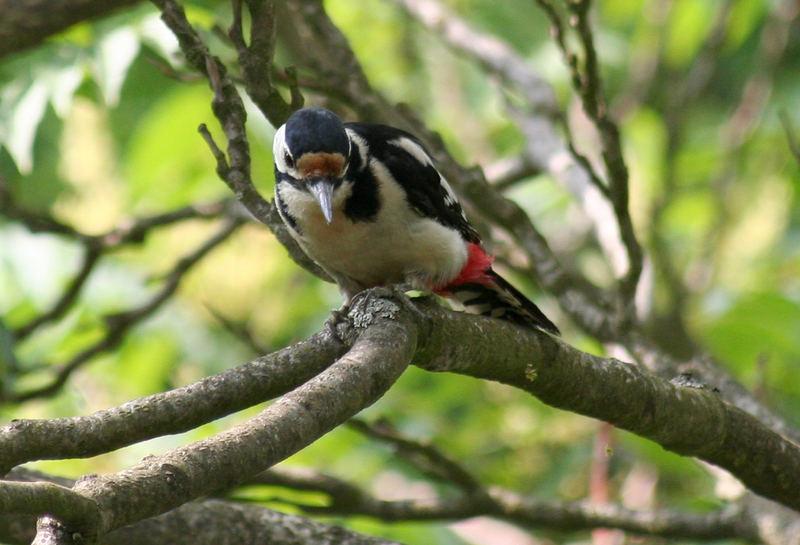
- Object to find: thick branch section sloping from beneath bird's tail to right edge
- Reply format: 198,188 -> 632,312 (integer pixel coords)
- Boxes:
406,296 -> 800,510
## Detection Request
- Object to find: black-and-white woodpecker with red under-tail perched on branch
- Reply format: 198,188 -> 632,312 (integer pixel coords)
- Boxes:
273,108 -> 558,334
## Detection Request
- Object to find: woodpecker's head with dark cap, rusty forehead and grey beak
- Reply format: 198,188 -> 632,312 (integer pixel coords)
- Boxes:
273,108 -> 350,223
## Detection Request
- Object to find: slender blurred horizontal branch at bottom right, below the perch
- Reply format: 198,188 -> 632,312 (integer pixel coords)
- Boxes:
239,466 -> 760,542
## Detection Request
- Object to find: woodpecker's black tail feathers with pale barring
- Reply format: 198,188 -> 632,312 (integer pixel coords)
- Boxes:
447,269 -> 560,335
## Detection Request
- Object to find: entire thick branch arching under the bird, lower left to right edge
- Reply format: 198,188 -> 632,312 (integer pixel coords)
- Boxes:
6,288 -> 800,533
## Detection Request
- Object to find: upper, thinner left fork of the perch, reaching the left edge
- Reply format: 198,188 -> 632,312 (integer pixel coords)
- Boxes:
0,330 -> 345,472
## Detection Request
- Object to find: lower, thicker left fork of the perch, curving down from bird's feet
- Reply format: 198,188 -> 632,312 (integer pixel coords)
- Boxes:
18,299 -> 417,540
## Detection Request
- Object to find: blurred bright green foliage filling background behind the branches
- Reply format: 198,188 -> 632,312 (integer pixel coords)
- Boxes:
0,0 -> 800,543
